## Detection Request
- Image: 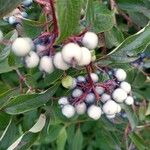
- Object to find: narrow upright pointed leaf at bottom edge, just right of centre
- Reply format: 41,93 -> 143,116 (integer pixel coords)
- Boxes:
72,128 -> 83,150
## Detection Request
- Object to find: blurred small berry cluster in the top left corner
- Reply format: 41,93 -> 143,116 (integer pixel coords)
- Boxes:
3,0 -> 33,25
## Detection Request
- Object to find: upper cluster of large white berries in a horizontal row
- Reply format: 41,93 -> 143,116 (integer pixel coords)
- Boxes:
12,32 -> 98,73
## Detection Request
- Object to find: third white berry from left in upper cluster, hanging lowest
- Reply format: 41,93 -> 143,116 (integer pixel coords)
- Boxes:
39,56 -> 54,73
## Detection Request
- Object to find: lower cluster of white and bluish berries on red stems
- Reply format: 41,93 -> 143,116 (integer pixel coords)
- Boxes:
58,69 -> 134,120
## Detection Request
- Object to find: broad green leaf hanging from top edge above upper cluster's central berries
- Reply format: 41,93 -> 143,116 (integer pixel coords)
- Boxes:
56,0 -> 82,43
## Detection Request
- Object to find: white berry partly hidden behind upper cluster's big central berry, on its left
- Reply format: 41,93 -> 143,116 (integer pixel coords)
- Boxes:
53,52 -> 70,70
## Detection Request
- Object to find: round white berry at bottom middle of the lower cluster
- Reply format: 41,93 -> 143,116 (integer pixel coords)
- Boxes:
87,105 -> 102,120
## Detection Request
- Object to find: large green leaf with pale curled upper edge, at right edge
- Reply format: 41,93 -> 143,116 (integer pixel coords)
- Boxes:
109,24 -> 150,63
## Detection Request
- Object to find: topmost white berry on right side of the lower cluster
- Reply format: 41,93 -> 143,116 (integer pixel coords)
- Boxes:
114,69 -> 127,81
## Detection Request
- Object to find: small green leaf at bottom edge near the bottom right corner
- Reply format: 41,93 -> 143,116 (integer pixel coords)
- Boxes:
129,132 -> 146,150
